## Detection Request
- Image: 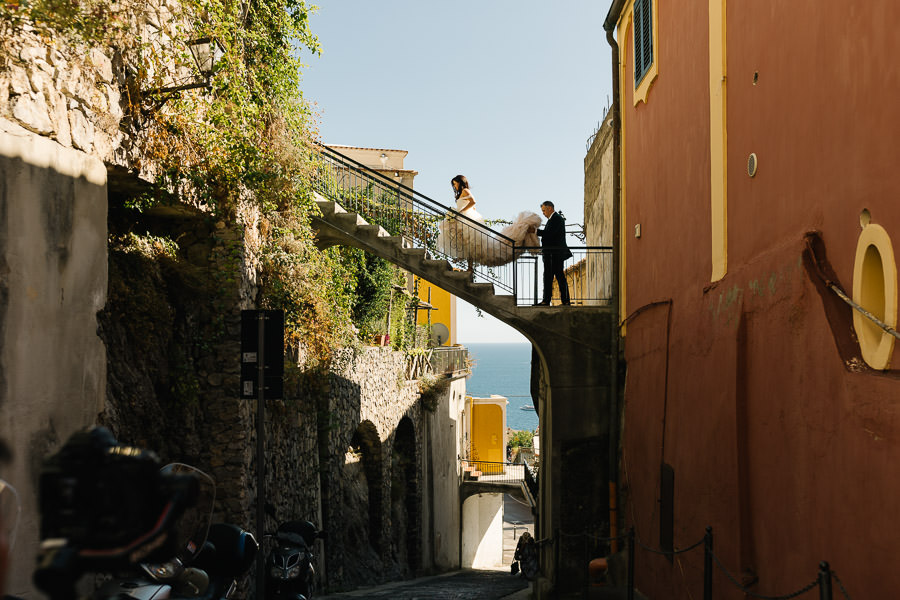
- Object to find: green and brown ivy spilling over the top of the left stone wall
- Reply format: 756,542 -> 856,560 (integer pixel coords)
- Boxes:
0,0 -> 414,363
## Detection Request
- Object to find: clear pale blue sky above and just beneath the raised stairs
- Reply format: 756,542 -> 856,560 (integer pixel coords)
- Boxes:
302,0 -> 611,344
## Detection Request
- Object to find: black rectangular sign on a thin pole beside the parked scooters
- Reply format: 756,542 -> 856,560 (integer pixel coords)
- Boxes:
240,310 -> 284,600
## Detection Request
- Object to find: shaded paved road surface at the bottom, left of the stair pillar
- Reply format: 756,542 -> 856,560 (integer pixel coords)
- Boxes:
323,569 -> 528,600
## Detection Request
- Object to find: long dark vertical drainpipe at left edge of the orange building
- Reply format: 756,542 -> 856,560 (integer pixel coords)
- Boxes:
603,0 -> 625,553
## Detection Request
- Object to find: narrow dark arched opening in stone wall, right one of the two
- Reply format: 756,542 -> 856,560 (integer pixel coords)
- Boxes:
391,417 -> 421,575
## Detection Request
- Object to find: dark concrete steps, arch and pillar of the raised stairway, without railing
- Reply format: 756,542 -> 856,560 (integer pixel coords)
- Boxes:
312,195 -> 618,597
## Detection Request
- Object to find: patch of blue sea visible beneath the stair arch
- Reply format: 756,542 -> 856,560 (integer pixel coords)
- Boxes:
463,344 -> 538,431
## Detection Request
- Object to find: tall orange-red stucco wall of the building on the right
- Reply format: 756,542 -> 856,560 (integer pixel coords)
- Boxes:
620,0 -> 900,599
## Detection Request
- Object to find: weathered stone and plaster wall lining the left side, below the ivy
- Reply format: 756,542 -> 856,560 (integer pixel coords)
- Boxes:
0,17 -> 465,597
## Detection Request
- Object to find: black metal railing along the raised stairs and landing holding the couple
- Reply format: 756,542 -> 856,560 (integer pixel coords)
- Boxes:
311,146 -> 613,305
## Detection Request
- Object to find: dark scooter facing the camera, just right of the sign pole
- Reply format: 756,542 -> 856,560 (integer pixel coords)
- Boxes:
266,521 -> 324,600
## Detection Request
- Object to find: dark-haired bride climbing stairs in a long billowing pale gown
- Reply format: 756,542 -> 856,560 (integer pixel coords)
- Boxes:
437,175 -> 541,272
